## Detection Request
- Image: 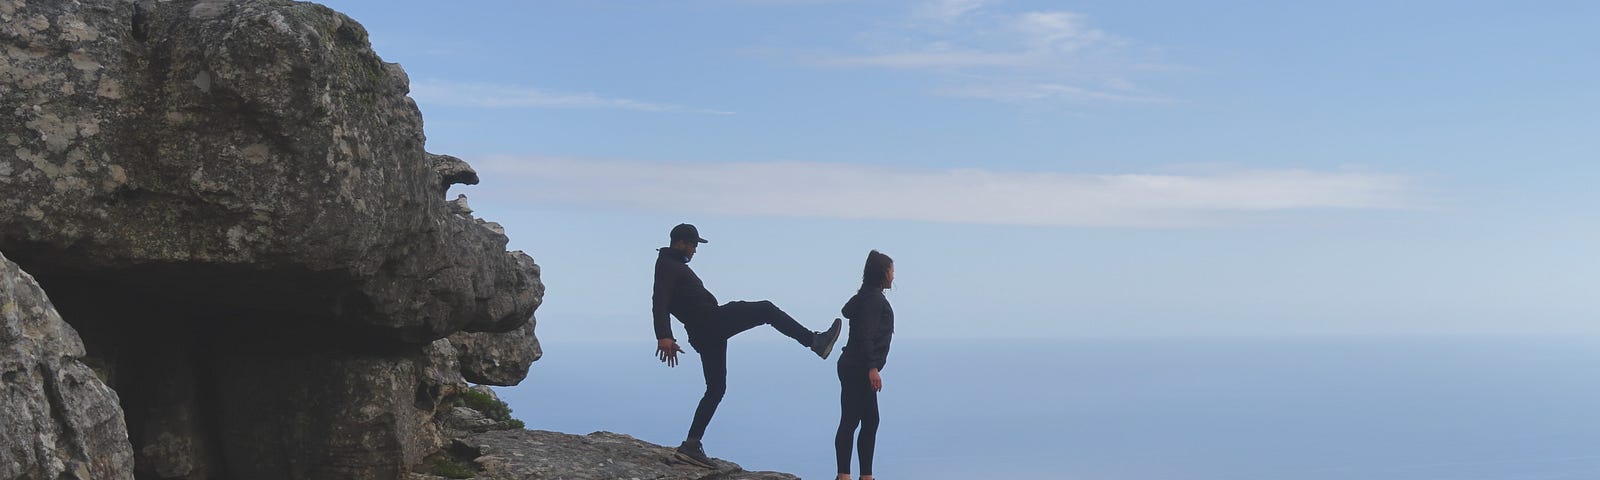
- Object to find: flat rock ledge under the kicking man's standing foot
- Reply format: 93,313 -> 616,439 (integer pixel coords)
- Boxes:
441,429 -> 800,480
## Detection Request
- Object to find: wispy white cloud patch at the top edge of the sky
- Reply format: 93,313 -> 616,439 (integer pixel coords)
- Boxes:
811,0 -> 1160,102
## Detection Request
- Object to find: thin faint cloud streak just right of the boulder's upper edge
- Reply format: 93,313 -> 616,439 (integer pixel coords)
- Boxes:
411,80 -> 733,115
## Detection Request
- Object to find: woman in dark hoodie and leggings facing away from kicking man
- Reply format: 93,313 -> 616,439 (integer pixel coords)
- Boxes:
834,250 -> 894,480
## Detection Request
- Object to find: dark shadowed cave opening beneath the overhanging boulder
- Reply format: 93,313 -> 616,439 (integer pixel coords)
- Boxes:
8,251 -> 440,480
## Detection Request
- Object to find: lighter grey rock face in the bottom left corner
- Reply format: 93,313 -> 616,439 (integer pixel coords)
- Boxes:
0,251 -> 133,480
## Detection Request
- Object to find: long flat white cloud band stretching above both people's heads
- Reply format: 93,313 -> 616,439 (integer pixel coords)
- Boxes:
474,157 -> 1411,227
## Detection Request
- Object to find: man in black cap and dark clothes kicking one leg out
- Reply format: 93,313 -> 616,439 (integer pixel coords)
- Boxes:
651,224 -> 842,469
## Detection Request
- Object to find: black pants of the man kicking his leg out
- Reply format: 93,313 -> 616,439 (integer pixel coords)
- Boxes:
683,301 -> 816,440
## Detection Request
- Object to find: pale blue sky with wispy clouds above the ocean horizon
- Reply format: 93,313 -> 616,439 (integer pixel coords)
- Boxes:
325,0 -> 1600,339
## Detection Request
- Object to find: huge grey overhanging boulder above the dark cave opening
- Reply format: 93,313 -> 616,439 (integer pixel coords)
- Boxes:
0,0 -> 538,342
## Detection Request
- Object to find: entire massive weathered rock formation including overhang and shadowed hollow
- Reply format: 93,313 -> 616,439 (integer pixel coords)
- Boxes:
0,0 -> 544,478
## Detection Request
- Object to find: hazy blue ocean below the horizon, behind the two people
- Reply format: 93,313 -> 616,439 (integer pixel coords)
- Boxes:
501,336 -> 1600,480
